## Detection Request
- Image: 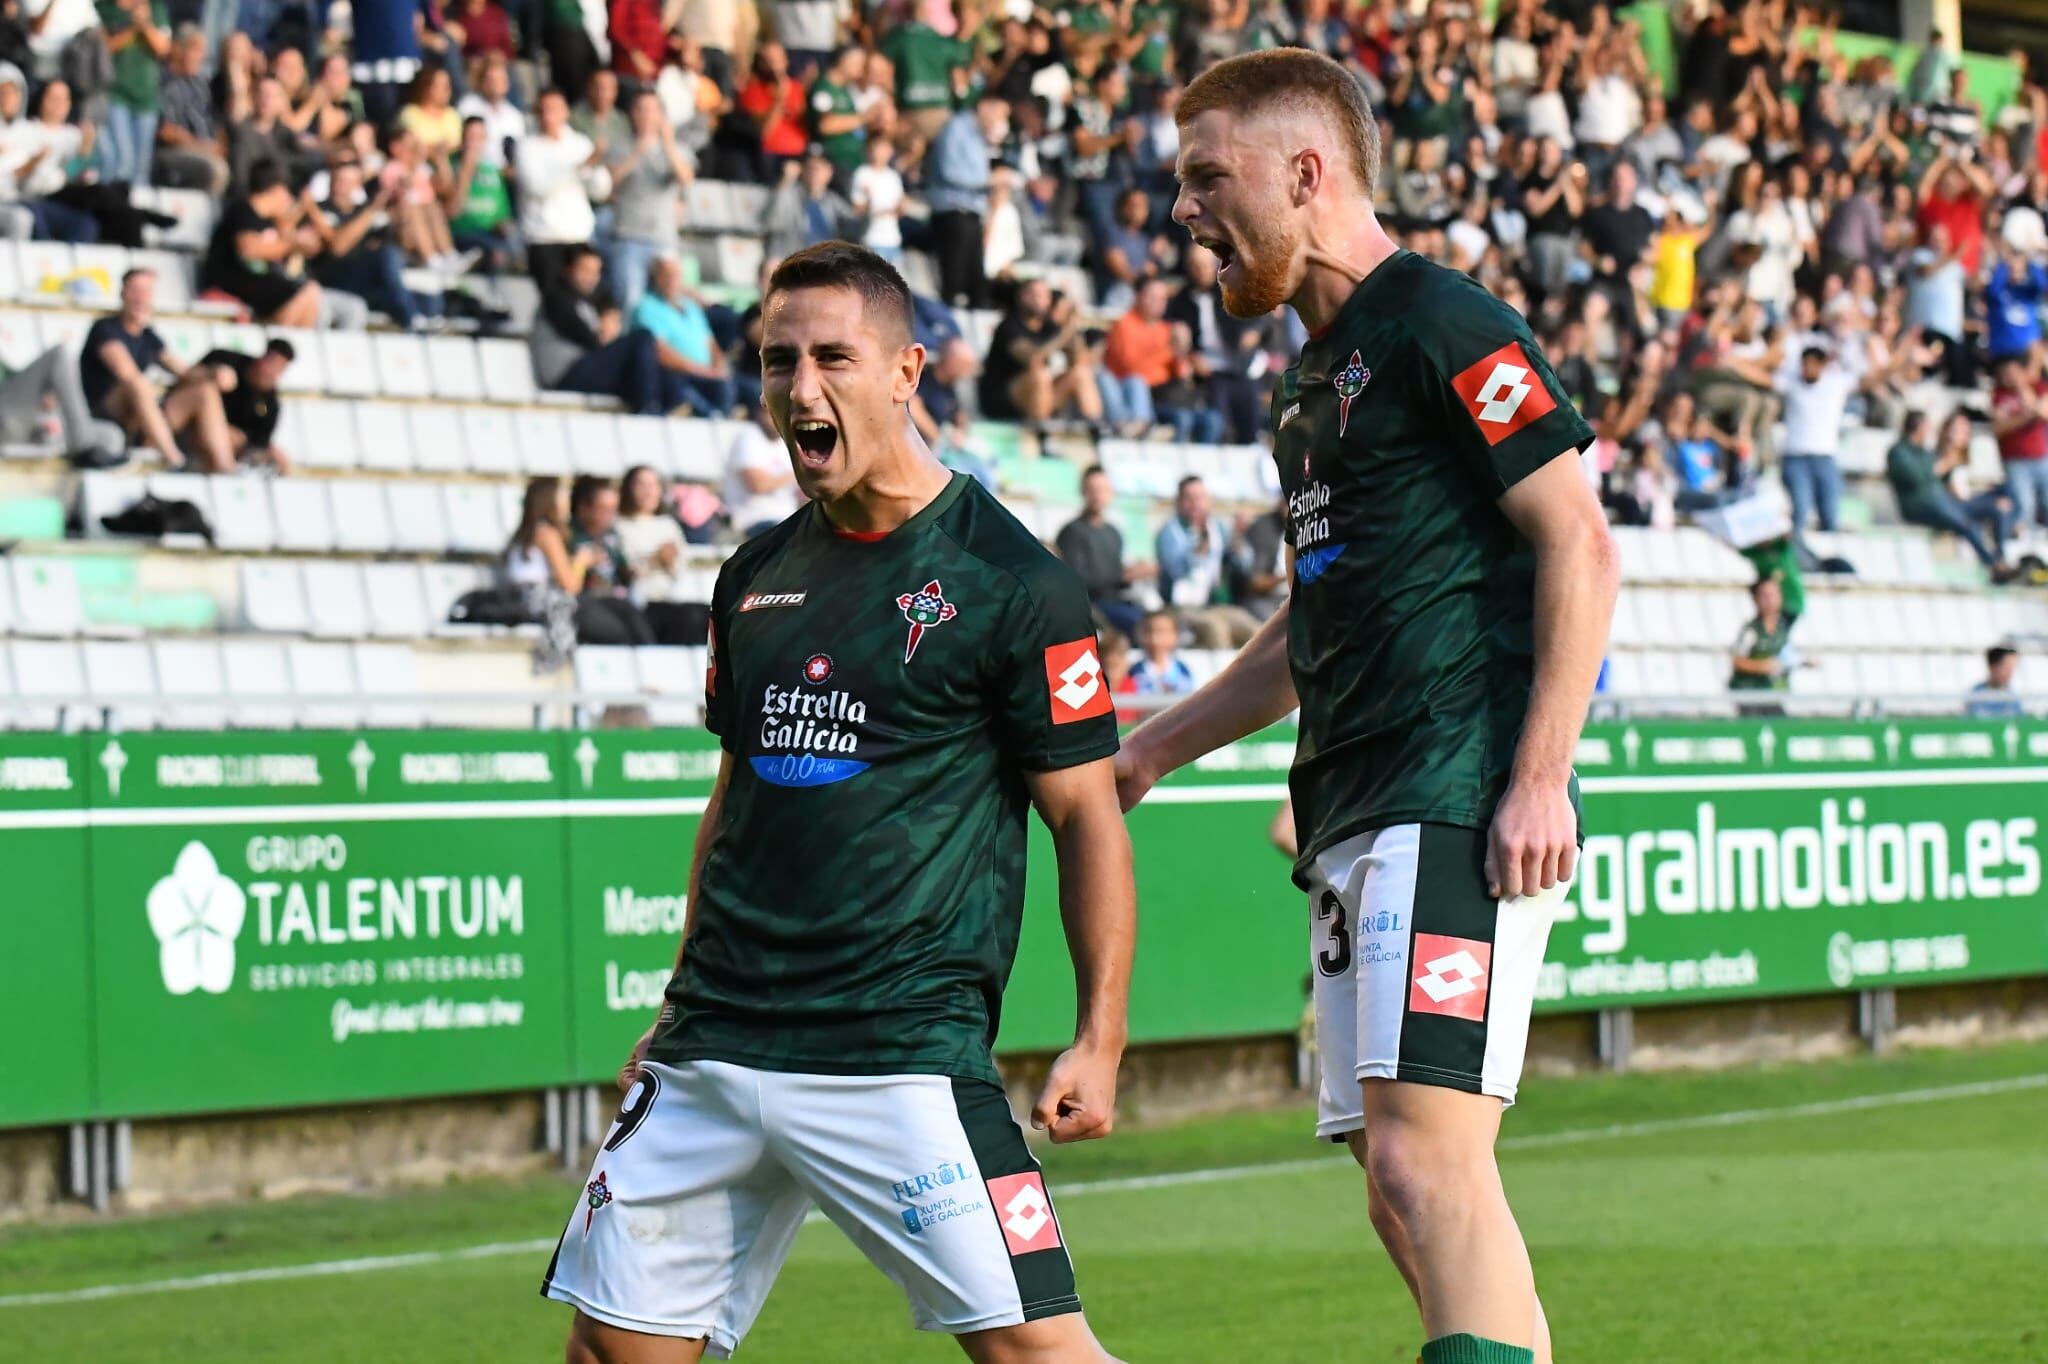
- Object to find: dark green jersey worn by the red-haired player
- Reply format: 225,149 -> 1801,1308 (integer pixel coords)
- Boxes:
1272,250 -> 1593,879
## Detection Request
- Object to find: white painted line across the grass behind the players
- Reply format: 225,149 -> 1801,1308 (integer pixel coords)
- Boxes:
0,1075 -> 2048,1309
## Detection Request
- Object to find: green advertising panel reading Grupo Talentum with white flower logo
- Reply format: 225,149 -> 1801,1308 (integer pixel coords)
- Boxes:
88,733 -> 569,1114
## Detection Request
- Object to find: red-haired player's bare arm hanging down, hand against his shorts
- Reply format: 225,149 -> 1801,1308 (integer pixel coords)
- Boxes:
1487,451 -> 1622,899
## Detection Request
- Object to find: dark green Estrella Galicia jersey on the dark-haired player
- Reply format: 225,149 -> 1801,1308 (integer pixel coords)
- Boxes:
649,475 -> 1116,1079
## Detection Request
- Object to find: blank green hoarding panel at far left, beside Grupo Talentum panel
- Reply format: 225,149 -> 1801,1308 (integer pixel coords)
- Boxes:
0,733 -> 94,1124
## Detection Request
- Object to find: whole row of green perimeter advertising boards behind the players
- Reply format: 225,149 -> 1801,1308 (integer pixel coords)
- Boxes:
0,721 -> 2048,1126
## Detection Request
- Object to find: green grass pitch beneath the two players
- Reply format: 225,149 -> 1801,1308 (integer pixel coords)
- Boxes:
0,1045 -> 2048,1364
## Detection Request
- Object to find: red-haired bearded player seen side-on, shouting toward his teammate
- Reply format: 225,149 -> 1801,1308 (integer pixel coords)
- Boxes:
1116,47 -> 1618,1364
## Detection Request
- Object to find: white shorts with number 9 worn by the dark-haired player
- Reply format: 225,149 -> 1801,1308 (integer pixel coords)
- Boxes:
541,1061 -> 1081,1358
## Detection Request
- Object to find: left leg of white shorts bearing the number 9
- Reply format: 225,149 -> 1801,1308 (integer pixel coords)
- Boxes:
541,1061 -> 805,1358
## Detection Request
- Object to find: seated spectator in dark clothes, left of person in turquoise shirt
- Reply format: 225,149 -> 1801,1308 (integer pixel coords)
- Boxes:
532,246 -> 682,416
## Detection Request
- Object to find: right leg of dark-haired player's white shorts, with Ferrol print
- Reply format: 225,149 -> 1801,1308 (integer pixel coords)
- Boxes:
764,1075 -> 1081,1335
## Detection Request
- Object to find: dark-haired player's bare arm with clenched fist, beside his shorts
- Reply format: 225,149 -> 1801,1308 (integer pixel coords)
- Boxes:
1024,758 -> 1137,1143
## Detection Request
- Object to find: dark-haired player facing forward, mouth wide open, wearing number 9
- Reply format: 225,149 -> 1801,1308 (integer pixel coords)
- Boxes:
543,242 -> 1137,1364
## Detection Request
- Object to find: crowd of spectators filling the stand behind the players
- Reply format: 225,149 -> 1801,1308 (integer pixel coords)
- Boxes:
0,0 -> 2048,678
